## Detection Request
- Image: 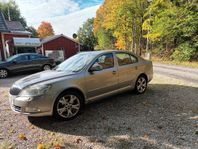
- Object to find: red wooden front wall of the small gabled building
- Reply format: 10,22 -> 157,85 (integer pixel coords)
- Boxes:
43,37 -> 79,59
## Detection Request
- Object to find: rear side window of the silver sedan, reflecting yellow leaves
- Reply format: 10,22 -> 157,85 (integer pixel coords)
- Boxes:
116,53 -> 137,66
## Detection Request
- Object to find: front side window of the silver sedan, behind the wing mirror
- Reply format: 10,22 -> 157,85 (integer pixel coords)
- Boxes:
93,53 -> 114,69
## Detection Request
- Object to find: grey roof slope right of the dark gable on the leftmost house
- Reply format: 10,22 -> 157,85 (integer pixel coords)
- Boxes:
6,21 -> 25,31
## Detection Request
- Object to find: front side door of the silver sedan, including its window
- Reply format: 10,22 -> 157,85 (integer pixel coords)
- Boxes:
86,53 -> 118,99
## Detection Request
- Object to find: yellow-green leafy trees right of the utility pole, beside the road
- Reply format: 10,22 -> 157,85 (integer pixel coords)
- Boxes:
143,0 -> 198,61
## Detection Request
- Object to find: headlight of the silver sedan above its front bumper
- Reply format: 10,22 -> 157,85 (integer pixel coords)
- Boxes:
20,84 -> 51,96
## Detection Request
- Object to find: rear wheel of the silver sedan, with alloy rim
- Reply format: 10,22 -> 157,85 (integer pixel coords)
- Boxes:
135,75 -> 148,94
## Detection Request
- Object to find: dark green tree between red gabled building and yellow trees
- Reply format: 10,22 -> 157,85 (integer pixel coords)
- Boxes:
77,18 -> 97,51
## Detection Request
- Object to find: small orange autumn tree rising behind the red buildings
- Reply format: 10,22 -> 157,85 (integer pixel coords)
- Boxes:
37,21 -> 54,38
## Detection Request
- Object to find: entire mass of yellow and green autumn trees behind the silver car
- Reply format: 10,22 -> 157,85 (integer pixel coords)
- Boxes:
94,0 -> 198,61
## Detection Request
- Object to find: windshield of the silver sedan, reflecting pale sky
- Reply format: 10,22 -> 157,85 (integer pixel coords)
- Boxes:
55,52 -> 95,72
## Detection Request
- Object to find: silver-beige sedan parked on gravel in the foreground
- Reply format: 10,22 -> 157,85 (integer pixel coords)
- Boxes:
10,50 -> 153,120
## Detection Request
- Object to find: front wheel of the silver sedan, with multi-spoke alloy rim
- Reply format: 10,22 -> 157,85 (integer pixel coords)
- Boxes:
53,91 -> 83,120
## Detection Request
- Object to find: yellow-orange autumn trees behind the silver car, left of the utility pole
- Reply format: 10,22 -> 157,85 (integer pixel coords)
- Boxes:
94,0 -> 148,53
